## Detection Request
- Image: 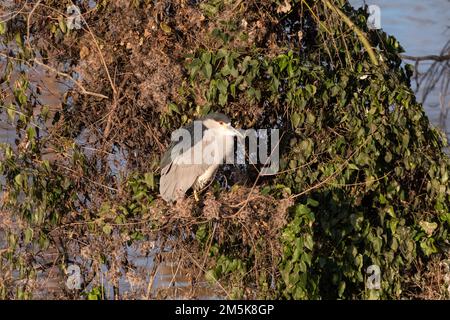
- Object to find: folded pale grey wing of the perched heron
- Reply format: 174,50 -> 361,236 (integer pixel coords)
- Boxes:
159,124 -> 210,202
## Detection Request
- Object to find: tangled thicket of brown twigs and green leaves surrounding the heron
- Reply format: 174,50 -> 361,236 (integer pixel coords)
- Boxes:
0,0 -> 450,299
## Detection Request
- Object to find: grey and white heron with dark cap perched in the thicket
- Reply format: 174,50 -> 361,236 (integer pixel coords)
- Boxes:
159,113 -> 243,203
